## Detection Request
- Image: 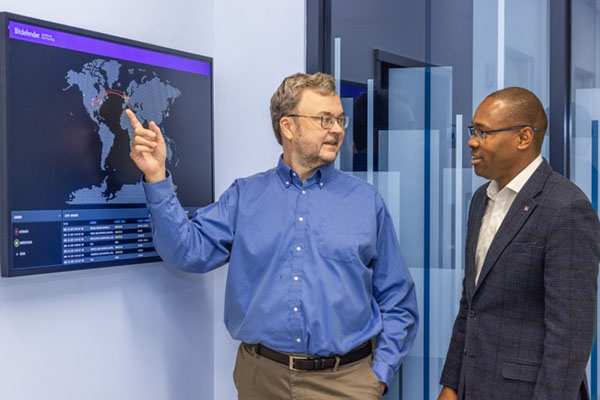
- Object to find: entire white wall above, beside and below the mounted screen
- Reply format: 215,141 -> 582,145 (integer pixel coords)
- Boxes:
0,0 -> 305,400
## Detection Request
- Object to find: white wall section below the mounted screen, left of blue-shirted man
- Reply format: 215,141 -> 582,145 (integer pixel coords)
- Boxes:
0,264 -> 213,400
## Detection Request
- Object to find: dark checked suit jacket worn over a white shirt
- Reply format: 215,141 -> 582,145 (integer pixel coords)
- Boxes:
440,161 -> 600,400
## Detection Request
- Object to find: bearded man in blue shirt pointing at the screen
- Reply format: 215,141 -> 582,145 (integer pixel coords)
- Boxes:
127,73 -> 418,400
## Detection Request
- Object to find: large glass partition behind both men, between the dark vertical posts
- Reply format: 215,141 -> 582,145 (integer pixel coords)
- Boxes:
326,0 -> 549,400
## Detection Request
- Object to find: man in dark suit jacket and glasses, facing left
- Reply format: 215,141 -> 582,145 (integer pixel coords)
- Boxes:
439,88 -> 600,400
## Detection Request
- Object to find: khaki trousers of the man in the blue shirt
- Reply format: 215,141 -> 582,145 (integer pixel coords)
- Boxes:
233,343 -> 381,400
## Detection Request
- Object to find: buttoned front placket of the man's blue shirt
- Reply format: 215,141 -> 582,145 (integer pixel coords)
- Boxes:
289,177 -> 309,353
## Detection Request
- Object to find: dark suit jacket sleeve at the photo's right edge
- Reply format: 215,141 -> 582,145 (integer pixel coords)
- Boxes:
534,199 -> 600,400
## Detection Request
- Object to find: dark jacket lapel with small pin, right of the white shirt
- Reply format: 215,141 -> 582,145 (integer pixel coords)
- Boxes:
473,160 -> 552,295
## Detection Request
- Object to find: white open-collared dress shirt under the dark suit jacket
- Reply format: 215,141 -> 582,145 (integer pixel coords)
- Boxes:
475,154 -> 542,285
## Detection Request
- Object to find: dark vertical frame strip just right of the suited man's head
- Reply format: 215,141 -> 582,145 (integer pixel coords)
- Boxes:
548,0 -> 571,178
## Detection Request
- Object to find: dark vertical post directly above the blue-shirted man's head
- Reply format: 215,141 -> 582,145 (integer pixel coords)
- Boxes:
306,0 -> 332,74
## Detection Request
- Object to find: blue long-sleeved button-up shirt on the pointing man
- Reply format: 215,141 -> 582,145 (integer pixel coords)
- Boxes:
144,159 -> 418,386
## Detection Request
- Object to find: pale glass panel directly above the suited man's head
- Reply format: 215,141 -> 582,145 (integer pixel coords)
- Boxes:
469,0 -> 550,159
